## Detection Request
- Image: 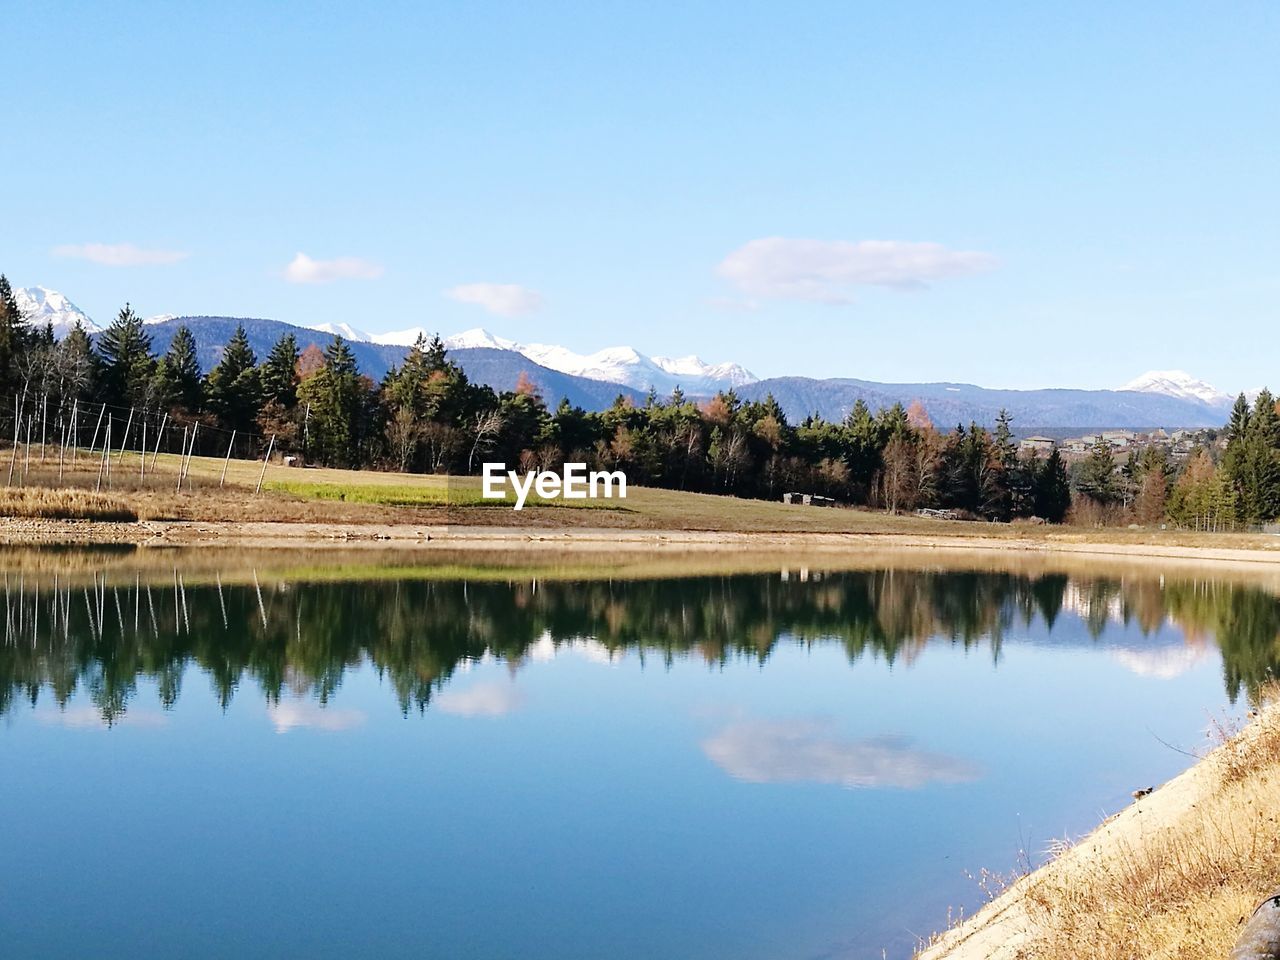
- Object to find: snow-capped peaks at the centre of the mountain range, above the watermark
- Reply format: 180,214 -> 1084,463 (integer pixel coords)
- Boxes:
442,328 -> 758,394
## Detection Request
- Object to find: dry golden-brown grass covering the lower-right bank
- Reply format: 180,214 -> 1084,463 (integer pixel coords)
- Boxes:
945,705 -> 1280,960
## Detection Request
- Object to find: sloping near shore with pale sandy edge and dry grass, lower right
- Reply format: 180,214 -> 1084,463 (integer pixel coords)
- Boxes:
914,703 -> 1280,960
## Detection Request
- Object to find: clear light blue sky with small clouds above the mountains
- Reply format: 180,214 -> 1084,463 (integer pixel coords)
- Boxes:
0,3 -> 1280,390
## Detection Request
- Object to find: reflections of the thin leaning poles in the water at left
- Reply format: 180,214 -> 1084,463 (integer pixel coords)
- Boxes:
4,567 -> 266,649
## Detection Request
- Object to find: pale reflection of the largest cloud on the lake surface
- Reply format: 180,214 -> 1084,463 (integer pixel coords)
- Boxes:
701,719 -> 978,790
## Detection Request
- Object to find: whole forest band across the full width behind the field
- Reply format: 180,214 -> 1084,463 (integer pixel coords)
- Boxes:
0,276 -> 1280,531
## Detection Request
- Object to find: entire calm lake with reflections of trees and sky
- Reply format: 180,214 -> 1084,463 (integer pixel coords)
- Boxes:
0,550 -> 1280,960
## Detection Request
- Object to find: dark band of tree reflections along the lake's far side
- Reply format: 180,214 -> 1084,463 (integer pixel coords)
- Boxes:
0,570 -> 1280,723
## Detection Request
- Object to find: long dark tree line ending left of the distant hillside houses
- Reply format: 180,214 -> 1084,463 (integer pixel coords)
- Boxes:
0,278 -> 1070,522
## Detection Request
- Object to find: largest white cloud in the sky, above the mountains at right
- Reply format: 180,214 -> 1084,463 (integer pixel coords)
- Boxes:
717,237 -> 996,303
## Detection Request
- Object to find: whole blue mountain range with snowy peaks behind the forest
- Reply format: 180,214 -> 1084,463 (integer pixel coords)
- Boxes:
14,287 -> 1231,434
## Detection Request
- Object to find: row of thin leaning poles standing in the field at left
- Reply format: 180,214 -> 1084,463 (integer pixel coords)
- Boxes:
5,394 -> 275,495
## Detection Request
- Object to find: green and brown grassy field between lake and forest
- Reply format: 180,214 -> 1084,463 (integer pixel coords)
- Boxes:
0,447 -> 1280,550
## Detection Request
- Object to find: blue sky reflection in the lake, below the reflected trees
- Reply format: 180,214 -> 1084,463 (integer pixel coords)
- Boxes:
0,576 -> 1254,960
